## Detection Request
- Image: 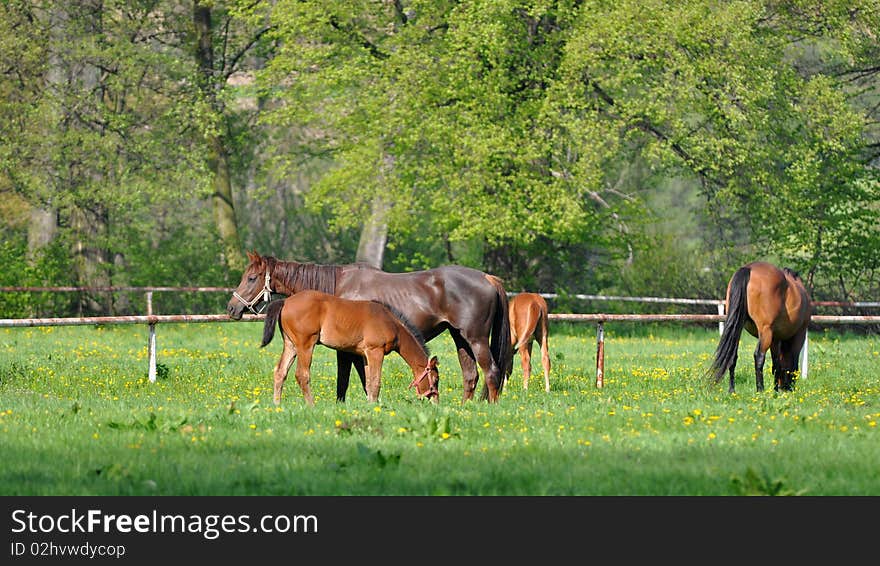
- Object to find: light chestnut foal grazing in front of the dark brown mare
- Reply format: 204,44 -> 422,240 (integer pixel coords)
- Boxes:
260,291 -> 440,405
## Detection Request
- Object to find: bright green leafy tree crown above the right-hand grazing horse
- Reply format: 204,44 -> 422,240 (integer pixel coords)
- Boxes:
553,0 -> 878,298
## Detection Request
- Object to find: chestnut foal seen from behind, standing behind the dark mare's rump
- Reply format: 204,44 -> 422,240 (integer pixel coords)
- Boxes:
507,293 -> 550,393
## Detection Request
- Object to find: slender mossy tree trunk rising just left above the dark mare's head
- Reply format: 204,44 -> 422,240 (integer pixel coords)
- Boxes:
193,0 -> 246,269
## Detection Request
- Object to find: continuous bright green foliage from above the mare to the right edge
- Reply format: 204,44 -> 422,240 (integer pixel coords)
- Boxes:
253,0 -> 877,293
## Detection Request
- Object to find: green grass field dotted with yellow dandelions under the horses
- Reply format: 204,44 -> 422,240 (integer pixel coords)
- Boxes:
0,322 -> 880,495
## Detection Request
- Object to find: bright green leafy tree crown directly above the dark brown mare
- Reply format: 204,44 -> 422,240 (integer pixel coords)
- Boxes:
263,2 -> 628,276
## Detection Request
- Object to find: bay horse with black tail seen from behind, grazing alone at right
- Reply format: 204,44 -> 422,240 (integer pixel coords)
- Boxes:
711,261 -> 812,393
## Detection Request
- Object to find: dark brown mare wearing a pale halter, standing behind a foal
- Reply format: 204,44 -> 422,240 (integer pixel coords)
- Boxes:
227,252 -> 512,402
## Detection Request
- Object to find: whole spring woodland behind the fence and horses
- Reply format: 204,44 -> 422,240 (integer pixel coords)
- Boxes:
0,0 -> 880,317
